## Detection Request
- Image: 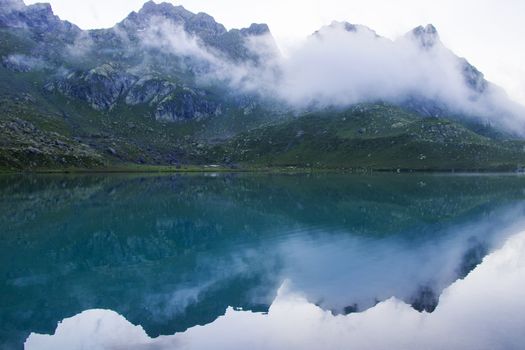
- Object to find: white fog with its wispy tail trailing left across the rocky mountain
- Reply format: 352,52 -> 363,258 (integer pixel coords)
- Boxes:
131,18 -> 525,132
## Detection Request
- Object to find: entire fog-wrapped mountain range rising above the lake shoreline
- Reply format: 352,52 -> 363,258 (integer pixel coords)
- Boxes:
0,0 -> 525,170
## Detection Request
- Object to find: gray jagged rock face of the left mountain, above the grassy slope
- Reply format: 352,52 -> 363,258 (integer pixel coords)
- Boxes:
0,0 -> 276,121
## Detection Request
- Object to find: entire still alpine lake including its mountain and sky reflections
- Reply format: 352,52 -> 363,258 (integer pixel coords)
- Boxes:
0,173 -> 525,349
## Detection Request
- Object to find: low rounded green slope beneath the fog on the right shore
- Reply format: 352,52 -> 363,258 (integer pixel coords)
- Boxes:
212,104 -> 525,171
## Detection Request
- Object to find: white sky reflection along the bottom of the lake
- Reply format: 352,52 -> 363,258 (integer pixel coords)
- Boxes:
25,228 -> 525,350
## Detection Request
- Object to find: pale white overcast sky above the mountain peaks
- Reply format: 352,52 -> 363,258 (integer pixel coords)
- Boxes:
25,0 -> 525,104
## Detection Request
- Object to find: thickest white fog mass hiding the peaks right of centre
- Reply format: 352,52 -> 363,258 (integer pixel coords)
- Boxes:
274,23 -> 467,105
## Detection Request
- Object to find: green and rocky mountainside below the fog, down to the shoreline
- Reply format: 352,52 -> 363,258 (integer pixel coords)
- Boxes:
0,16 -> 525,171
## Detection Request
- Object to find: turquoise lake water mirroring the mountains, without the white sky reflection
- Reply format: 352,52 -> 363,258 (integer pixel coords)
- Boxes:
0,174 -> 525,349
